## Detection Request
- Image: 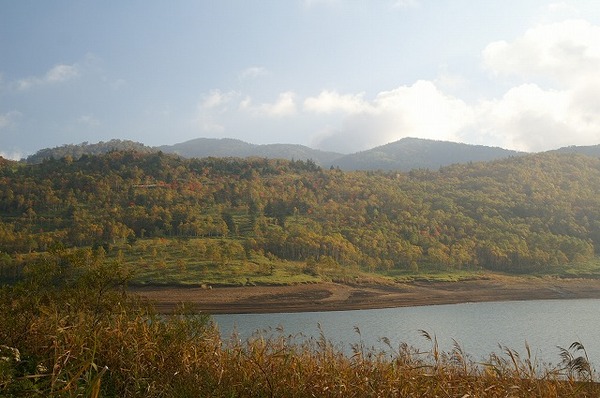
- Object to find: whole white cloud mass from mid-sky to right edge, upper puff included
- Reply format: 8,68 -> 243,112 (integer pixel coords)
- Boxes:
191,17 -> 600,152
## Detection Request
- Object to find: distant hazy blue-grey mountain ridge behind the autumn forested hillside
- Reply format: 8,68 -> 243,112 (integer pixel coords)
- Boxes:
24,137 -> 600,171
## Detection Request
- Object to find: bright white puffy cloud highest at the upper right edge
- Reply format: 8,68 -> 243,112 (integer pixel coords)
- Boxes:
483,19 -> 600,85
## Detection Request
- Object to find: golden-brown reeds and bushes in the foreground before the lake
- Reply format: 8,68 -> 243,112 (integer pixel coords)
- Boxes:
0,251 -> 600,398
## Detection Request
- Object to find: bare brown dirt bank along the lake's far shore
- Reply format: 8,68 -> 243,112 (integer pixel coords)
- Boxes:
131,277 -> 600,314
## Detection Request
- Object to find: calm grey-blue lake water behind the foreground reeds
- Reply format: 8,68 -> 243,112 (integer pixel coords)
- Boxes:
213,299 -> 600,364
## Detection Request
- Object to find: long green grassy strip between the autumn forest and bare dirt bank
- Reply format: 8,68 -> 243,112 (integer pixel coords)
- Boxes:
96,238 -> 600,286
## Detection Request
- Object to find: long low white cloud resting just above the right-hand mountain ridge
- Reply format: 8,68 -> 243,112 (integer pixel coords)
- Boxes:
305,74 -> 600,152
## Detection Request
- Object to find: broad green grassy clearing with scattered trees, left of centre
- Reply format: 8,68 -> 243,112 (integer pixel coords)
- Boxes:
108,238 -> 321,286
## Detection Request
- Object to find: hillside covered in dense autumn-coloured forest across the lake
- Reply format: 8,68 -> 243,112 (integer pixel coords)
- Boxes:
0,152 -> 600,272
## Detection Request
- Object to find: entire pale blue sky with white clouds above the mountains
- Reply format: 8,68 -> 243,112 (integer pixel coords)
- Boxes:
0,0 -> 600,159
